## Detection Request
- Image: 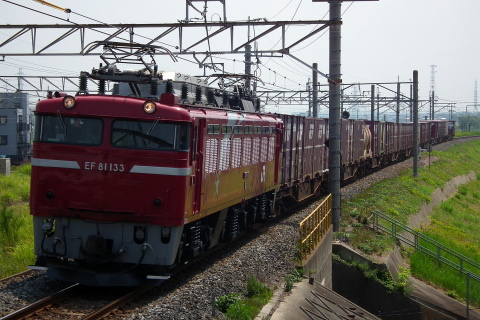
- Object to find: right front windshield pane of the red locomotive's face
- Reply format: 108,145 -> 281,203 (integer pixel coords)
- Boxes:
111,120 -> 190,151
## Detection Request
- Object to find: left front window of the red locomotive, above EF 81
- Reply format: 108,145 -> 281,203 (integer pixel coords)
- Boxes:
34,113 -> 103,146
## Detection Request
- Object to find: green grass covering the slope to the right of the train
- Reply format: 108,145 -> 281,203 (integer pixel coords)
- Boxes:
340,141 -> 480,305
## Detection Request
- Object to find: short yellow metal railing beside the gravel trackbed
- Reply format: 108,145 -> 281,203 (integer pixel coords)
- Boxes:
299,194 -> 332,263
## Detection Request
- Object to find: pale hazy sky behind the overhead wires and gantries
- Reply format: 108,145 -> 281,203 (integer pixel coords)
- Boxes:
0,0 -> 480,117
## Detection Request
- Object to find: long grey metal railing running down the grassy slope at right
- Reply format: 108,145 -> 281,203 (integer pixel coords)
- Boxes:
372,211 -> 480,319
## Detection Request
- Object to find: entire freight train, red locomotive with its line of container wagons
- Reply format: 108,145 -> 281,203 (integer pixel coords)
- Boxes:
30,65 -> 454,286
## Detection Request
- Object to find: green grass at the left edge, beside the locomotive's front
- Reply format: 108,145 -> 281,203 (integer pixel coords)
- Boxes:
0,165 -> 34,278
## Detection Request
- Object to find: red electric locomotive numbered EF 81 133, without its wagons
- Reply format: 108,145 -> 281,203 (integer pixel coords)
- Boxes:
30,63 -> 282,286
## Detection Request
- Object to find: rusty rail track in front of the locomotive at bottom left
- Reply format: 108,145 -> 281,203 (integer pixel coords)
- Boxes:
0,284 -> 152,320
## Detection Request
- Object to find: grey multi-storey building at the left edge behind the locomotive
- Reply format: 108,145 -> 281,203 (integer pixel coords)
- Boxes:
0,93 -> 32,163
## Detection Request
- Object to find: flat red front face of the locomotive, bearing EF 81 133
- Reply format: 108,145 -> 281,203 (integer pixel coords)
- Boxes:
30,96 -> 193,285
